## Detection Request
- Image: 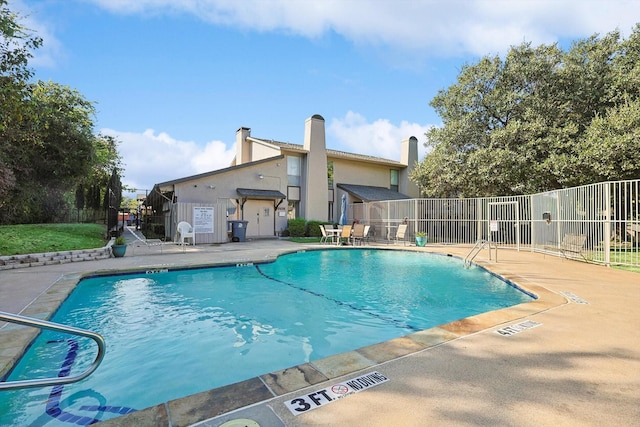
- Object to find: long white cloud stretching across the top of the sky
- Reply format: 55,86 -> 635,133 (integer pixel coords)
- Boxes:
89,0 -> 640,56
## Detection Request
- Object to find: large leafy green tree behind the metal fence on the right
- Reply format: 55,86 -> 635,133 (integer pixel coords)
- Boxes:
412,26 -> 640,197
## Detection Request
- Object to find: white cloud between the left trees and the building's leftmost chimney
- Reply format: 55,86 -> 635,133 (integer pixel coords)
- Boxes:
101,129 -> 235,194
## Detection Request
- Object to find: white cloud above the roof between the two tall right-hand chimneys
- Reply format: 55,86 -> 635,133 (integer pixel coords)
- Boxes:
327,111 -> 432,160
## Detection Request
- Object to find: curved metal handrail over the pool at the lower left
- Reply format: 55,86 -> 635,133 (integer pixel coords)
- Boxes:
0,311 -> 106,391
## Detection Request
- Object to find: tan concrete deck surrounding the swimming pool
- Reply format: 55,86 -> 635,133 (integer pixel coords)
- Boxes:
0,240 -> 640,427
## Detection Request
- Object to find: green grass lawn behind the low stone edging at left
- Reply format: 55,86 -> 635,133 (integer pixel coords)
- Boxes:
0,224 -> 106,255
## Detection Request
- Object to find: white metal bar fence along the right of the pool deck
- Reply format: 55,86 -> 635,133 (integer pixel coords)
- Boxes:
349,180 -> 640,266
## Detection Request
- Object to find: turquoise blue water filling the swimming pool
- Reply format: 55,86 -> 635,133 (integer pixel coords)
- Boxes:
0,249 -> 532,425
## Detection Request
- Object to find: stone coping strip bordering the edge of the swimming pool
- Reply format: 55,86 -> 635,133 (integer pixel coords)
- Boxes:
0,246 -> 568,426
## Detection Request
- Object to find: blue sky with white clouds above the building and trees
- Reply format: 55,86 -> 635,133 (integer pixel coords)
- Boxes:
8,0 -> 640,197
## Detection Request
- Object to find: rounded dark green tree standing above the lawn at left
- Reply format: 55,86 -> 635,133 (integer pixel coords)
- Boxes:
0,82 -> 96,223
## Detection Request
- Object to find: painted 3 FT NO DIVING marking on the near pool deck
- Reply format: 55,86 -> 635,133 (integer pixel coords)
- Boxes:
284,371 -> 389,416
